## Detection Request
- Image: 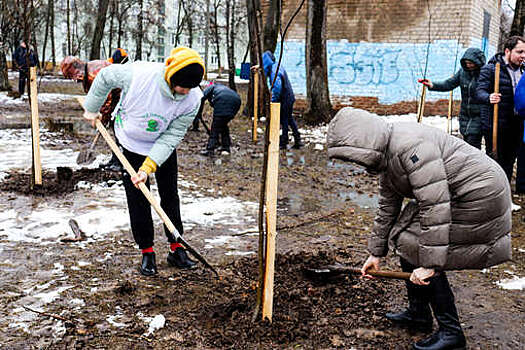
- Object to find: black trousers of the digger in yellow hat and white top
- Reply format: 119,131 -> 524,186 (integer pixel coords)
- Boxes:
122,149 -> 183,249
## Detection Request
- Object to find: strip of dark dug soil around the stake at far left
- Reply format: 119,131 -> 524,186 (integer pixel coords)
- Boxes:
0,167 -> 121,196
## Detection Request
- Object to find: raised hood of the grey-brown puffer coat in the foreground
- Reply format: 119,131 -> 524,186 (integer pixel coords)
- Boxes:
326,107 -> 391,172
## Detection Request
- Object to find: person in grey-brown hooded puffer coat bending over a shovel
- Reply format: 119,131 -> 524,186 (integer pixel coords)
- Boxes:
327,108 -> 512,349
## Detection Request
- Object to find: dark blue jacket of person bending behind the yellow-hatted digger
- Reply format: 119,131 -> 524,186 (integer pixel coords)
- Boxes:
202,83 -> 241,117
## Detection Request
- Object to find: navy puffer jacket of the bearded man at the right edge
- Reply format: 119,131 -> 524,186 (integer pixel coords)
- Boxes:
476,53 -> 519,132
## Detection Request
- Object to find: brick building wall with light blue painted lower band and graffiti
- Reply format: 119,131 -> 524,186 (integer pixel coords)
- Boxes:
263,0 -> 499,108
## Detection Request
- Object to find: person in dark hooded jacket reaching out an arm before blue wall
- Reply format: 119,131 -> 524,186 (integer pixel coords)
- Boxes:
418,47 -> 486,149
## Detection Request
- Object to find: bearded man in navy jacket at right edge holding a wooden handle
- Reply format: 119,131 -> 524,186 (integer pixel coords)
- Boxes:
476,35 -> 525,209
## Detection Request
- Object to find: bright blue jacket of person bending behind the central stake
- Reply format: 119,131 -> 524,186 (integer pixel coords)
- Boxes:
263,51 -> 295,104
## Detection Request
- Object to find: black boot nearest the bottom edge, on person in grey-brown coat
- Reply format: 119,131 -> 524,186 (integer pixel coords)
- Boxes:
413,272 -> 466,350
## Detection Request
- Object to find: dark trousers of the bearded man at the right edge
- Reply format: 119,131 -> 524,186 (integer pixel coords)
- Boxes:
485,121 -> 523,183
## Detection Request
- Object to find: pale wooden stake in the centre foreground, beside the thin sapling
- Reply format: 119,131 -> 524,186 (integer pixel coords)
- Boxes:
262,103 -> 281,322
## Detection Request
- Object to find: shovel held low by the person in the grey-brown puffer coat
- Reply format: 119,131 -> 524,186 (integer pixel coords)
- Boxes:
303,264 -> 410,281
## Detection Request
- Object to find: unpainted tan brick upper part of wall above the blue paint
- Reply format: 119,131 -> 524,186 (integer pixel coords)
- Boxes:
274,0 -> 499,46
